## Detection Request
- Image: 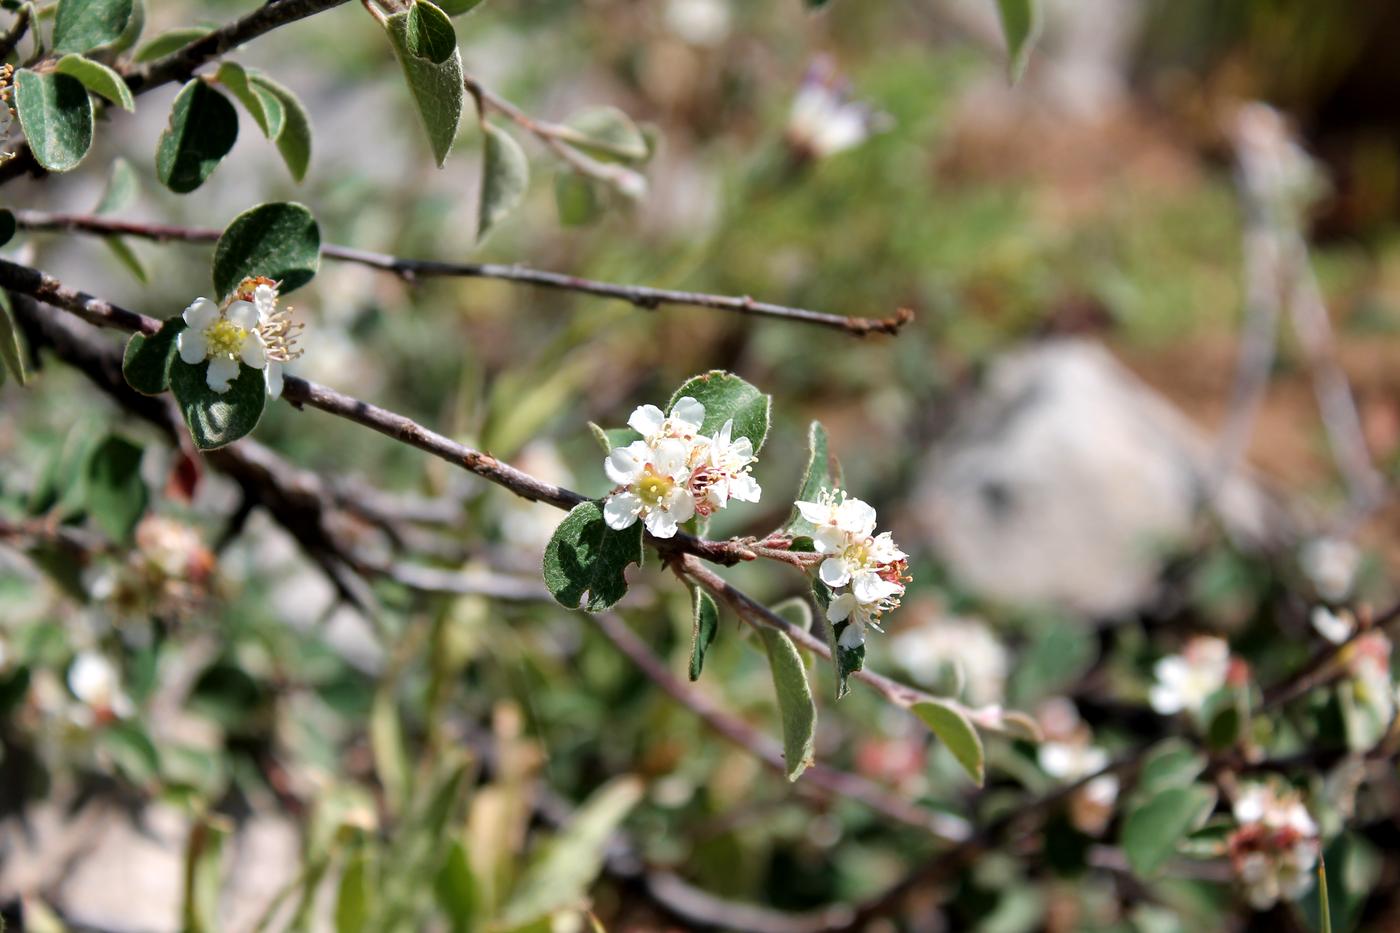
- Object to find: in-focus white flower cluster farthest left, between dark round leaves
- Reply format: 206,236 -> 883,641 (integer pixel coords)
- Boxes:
176,277 -> 301,398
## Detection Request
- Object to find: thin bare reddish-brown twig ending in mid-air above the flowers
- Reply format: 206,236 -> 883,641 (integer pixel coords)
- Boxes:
15,210 -> 914,336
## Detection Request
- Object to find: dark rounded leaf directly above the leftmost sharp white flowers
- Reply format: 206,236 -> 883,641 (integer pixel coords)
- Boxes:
214,200 -> 321,298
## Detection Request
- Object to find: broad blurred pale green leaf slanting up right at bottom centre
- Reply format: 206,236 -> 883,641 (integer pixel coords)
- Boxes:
500,776 -> 643,925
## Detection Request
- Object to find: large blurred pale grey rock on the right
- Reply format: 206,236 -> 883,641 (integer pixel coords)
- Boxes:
916,339 -> 1285,618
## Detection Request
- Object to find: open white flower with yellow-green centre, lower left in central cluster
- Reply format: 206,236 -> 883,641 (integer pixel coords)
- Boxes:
603,437 -> 696,538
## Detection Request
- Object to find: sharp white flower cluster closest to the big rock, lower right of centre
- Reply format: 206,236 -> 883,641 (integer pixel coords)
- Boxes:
795,490 -> 909,649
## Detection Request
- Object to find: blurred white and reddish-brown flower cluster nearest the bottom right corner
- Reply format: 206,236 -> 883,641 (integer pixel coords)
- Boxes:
1229,785 -> 1317,911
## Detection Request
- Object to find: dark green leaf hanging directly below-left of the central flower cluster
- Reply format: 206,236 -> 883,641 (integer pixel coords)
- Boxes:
543,502 -> 641,612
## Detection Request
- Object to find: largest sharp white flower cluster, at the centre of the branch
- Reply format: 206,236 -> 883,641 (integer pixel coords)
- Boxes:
603,395 -> 763,538
